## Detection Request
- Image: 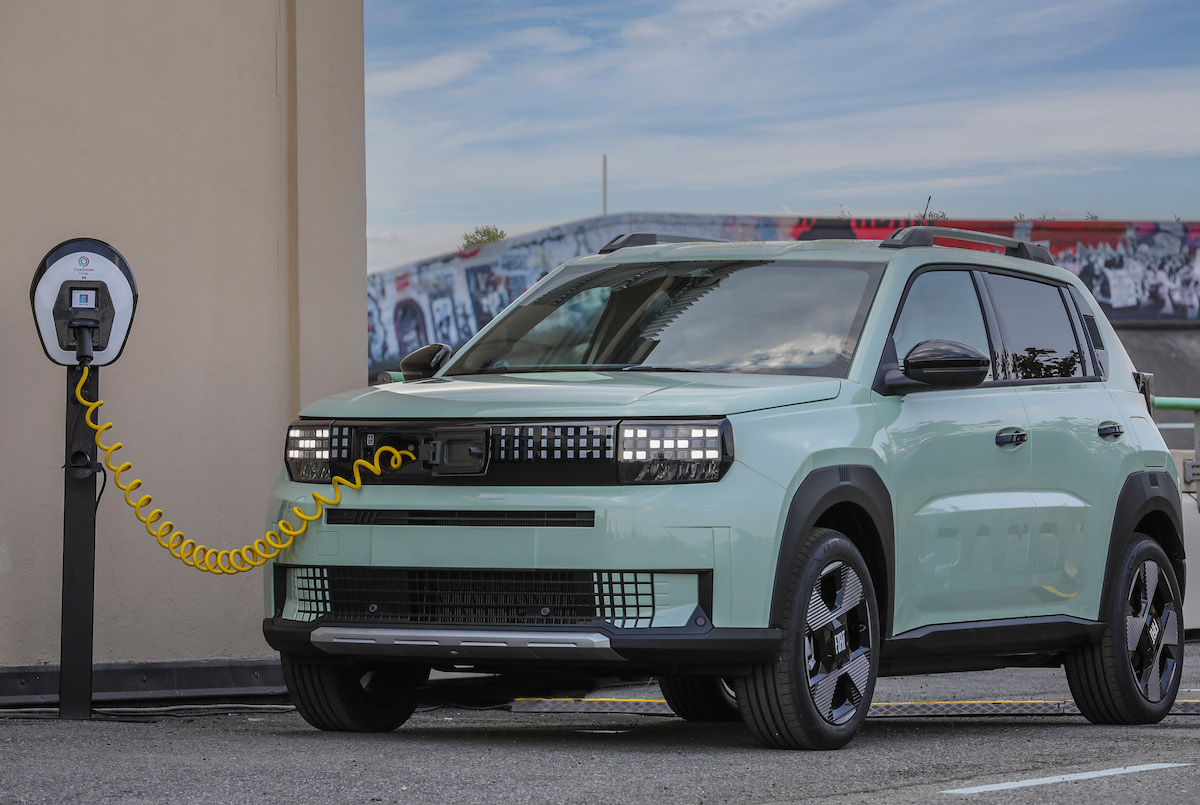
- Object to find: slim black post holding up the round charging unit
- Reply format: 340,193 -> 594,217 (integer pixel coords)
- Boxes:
59,366 -> 100,720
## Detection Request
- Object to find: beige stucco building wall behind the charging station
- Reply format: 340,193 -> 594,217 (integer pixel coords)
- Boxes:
0,0 -> 366,667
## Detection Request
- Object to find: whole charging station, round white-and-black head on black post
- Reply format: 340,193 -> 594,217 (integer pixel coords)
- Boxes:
29,238 -> 138,719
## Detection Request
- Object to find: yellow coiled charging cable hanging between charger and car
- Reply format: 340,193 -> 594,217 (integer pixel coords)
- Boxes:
76,366 -> 416,575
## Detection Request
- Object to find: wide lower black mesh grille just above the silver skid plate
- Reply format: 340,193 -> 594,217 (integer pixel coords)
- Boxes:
280,566 -> 654,629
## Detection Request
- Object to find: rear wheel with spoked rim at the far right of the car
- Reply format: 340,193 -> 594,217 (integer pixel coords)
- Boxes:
1066,534 -> 1183,723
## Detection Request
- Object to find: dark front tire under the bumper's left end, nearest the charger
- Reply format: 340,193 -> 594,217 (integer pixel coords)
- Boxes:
280,654 -> 430,732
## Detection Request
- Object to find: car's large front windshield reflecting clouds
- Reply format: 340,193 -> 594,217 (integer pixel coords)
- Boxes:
446,260 -> 883,377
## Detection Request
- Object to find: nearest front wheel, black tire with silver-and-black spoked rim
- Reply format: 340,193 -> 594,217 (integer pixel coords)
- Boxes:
737,528 -> 880,750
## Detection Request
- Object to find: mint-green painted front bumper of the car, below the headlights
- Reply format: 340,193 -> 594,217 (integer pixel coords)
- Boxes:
264,463 -> 786,629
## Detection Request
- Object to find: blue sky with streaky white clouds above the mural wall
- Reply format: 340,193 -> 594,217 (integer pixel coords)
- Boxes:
365,0 -> 1200,271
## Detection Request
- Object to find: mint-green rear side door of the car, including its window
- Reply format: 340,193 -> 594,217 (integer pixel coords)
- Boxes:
985,272 -> 1138,618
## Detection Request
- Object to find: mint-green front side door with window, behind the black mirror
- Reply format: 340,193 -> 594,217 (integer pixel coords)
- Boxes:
876,268 -> 1036,635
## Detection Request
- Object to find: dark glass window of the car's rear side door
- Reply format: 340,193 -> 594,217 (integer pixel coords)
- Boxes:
988,274 -> 1084,380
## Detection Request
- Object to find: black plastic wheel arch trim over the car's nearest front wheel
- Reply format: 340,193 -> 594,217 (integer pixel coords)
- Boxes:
768,464 -> 895,639
